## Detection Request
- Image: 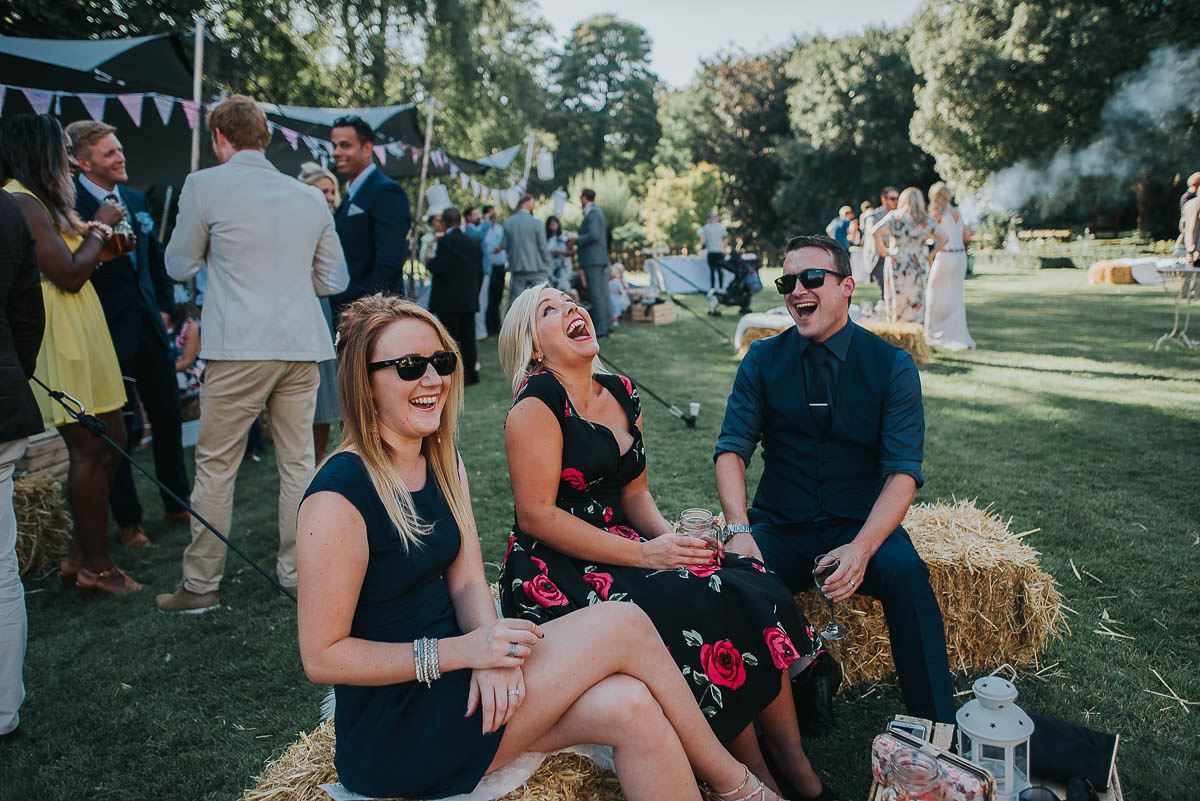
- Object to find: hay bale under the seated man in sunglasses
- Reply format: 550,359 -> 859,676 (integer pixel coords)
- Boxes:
796,500 -> 1064,685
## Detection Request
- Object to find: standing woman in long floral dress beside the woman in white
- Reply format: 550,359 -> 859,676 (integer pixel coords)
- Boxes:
871,186 -> 946,323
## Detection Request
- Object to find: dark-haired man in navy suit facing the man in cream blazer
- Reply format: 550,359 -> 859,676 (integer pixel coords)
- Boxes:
329,116 -> 413,315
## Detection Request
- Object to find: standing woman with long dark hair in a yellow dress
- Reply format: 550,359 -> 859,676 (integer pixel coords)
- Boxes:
0,114 -> 142,597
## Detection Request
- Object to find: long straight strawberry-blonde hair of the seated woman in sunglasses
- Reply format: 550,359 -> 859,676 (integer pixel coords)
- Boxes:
337,295 -> 469,549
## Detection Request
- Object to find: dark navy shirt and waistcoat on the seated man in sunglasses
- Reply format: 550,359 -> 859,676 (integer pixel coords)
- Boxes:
714,323 -> 925,525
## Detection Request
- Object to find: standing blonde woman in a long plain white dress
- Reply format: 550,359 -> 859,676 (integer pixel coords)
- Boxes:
925,181 -> 976,350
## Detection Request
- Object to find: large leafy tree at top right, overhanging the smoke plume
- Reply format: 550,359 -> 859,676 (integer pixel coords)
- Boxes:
910,0 -> 1198,187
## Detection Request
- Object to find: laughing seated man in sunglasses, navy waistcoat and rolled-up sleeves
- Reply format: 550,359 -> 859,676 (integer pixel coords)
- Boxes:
714,235 -> 954,723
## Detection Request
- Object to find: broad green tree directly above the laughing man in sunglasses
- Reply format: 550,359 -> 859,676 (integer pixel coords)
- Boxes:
775,28 -> 935,231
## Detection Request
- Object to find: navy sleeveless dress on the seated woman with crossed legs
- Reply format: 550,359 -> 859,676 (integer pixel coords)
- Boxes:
305,451 -> 503,799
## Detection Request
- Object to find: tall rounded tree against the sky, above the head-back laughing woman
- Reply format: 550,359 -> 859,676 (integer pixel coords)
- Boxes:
546,14 -> 662,175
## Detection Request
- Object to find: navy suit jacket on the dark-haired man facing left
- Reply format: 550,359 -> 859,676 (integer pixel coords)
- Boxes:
330,167 -> 412,314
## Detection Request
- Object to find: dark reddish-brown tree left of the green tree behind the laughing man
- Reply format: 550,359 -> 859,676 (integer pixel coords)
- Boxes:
692,48 -> 792,249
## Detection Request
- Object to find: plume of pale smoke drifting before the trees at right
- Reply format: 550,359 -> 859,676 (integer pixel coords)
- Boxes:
961,46 -> 1200,223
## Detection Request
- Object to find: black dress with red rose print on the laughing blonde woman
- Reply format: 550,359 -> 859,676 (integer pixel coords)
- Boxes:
500,372 -> 820,743
